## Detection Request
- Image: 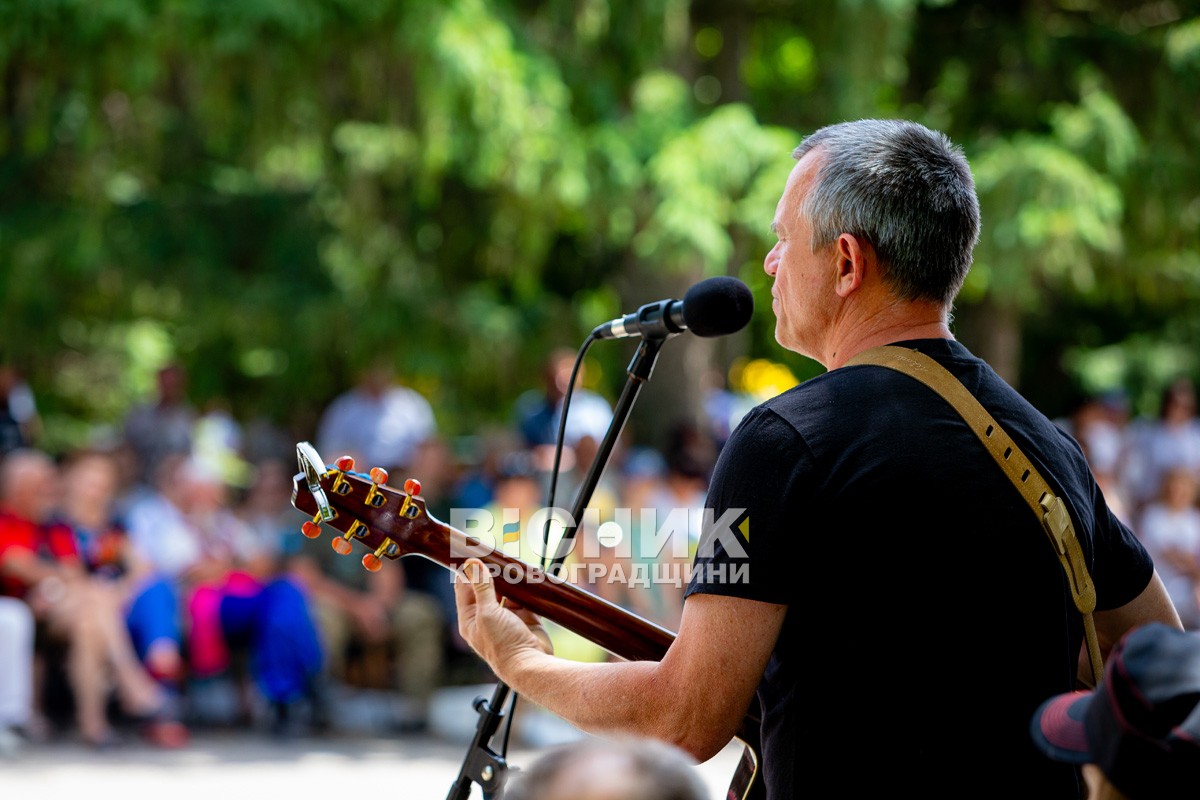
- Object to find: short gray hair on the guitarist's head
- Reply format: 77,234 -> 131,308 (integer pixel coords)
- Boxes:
792,120 -> 979,305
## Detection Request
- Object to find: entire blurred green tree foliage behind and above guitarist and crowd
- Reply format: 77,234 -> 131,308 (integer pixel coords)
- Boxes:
0,0 -> 1200,447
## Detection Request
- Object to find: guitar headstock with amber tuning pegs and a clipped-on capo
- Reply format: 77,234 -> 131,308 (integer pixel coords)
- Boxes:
292,441 -> 430,572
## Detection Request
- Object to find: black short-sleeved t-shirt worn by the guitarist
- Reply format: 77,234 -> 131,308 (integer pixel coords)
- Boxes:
688,339 -> 1153,800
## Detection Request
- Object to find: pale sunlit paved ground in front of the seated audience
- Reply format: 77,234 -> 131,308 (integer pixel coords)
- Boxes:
0,687 -> 740,800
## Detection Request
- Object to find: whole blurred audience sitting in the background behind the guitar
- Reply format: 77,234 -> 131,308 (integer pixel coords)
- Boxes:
9,351 -> 1200,754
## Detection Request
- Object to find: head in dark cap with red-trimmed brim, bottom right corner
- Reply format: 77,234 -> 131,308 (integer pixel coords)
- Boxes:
1031,622 -> 1200,800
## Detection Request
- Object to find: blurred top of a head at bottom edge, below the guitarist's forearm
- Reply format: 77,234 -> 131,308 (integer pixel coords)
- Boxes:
499,739 -> 708,800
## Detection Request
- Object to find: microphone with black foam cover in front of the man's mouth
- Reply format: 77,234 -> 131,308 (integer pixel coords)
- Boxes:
592,276 -> 754,339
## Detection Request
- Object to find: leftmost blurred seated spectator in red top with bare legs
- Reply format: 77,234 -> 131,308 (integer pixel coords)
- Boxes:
0,450 -> 181,747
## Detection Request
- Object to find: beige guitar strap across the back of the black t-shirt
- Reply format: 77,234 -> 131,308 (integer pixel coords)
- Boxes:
846,347 -> 1103,686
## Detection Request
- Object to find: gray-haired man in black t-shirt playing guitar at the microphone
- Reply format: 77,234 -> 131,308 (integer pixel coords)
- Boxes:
456,120 -> 1180,800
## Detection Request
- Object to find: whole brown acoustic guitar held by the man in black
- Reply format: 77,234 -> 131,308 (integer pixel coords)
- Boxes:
292,441 -> 766,800
